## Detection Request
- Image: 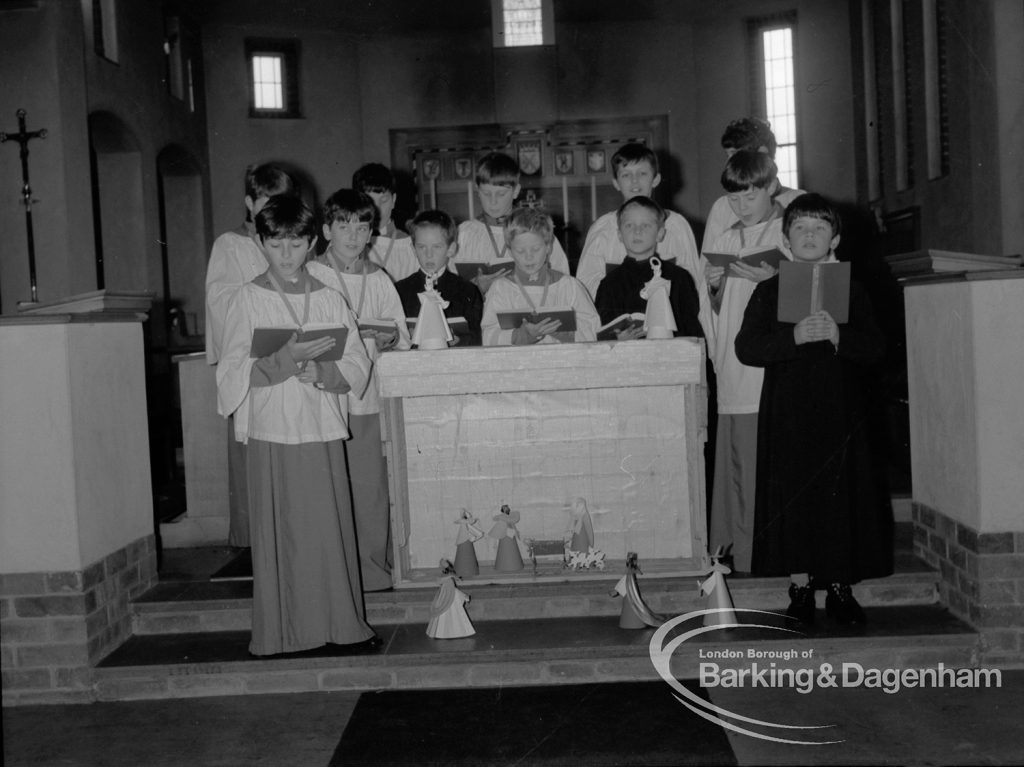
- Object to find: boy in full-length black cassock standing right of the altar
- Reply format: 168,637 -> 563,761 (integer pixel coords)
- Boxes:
736,195 -> 893,625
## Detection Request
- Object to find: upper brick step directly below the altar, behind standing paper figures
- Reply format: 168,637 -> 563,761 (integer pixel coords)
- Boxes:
132,552 -> 938,635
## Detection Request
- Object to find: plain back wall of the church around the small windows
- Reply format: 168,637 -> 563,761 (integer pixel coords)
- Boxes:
204,0 -> 856,246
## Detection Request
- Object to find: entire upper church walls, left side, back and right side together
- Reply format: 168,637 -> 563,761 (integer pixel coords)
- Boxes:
0,0 -> 1024,313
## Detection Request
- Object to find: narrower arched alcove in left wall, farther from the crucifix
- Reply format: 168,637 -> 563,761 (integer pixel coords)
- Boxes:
157,144 -> 207,347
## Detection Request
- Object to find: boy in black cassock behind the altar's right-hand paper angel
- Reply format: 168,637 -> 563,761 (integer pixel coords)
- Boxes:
594,196 -> 703,341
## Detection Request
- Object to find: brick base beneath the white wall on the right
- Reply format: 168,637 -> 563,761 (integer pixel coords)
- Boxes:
912,503 -> 1024,665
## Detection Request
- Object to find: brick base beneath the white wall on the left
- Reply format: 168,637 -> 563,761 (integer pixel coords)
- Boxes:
0,535 -> 157,706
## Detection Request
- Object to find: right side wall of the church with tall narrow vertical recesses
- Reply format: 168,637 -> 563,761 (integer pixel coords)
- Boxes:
857,0 -> 1024,255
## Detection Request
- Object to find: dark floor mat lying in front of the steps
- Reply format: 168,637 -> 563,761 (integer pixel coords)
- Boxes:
331,682 -> 736,767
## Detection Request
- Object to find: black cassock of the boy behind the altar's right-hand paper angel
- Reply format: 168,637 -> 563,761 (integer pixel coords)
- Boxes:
594,256 -> 703,338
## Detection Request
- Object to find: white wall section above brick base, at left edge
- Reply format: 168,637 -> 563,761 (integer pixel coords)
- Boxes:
0,322 -> 154,573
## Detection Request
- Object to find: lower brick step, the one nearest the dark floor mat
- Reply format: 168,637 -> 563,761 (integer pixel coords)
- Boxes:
93,604 -> 978,700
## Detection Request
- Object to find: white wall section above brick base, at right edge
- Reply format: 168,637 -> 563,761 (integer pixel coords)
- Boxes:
905,274 -> 1024,532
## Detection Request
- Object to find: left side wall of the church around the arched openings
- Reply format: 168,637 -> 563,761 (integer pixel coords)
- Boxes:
0,0 -> 209,325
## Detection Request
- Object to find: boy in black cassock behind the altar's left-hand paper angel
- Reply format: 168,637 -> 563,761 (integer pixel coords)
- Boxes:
394,210 -> 483,346
